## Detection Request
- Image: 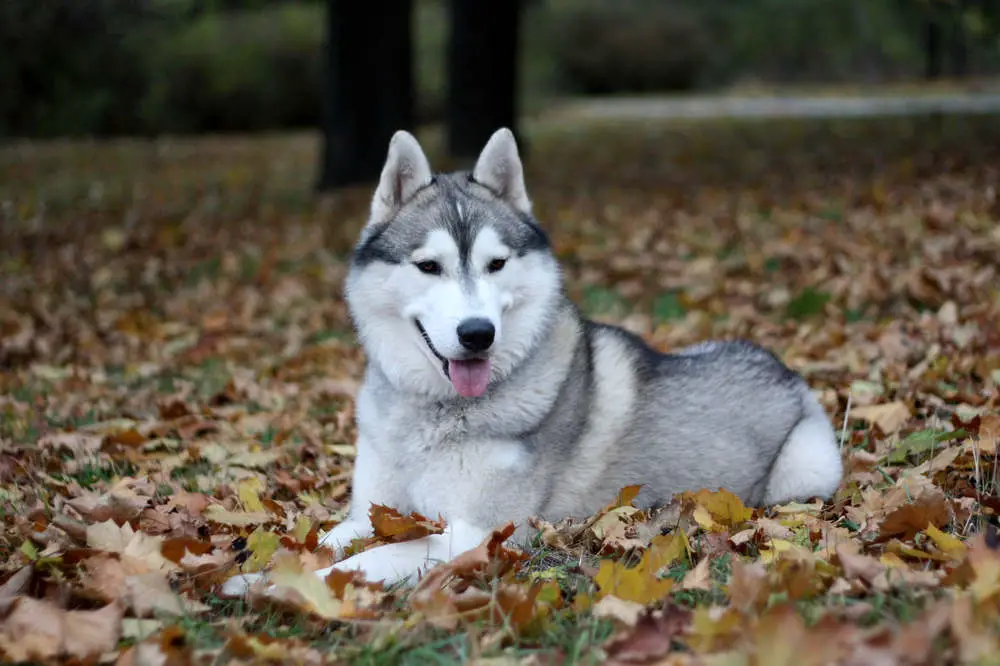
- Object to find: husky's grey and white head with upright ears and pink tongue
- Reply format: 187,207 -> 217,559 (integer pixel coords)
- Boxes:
347,129 -> 562,398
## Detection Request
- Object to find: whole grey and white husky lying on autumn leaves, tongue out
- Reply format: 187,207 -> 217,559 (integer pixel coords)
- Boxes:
221,128 -> 843,583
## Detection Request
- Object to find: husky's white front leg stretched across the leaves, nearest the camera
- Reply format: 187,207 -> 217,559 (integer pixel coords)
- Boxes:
316,520 -> 490,585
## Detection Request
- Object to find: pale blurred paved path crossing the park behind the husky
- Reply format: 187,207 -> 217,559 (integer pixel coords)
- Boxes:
549,92 -> 1000,122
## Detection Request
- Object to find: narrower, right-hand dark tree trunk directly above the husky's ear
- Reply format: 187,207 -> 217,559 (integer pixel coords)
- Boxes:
447,0 -> 524,159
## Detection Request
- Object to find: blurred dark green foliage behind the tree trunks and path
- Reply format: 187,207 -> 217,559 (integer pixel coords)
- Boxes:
0,0 -> 1000,136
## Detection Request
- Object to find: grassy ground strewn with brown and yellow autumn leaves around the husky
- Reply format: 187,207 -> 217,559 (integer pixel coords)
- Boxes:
0,117 -> 1000,665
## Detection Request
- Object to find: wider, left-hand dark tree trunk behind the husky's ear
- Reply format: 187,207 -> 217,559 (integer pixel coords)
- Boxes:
317,0 -> 413,190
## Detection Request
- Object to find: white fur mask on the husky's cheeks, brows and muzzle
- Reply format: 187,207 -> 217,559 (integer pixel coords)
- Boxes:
347,228 -> 561,398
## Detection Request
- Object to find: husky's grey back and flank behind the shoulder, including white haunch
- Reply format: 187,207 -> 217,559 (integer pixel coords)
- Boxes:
543,312 -> 841,516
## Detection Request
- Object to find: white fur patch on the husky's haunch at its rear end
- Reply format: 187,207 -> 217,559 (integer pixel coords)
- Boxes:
764,395 -> 843,504
